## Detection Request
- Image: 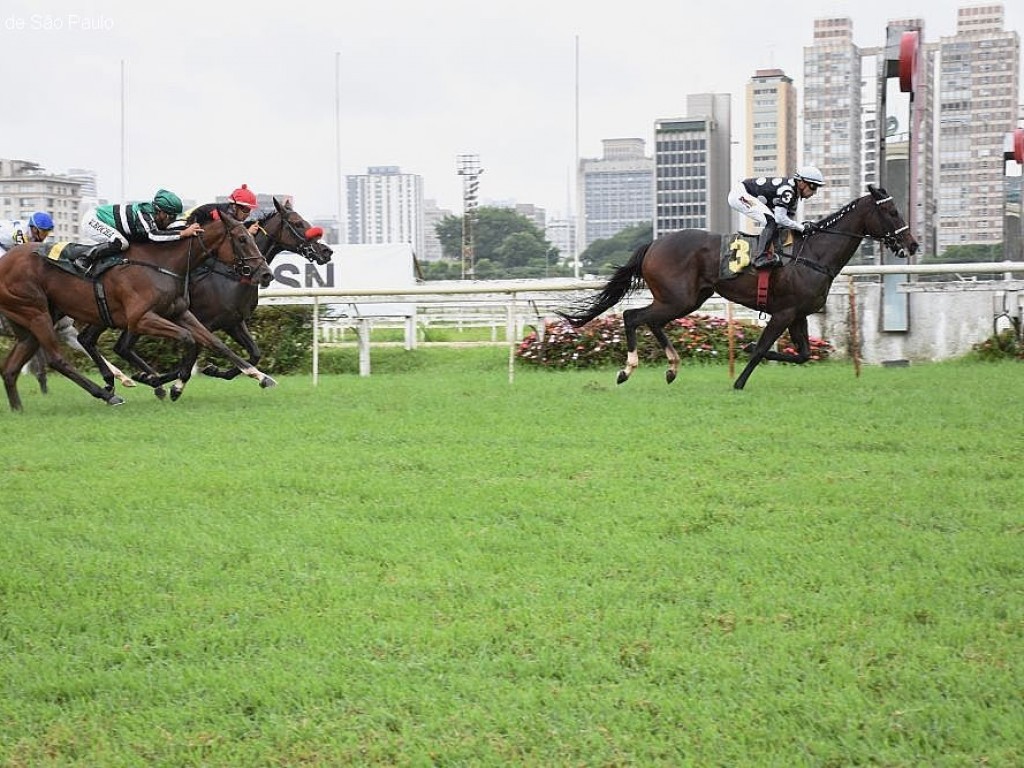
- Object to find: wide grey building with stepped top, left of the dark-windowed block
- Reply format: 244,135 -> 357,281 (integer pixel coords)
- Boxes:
581,138 -> 654,247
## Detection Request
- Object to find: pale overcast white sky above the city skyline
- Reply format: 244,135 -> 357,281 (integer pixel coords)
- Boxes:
0,0 -> 1024,218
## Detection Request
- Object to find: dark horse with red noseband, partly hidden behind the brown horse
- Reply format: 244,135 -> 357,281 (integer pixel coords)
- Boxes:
79,198 -> 333,396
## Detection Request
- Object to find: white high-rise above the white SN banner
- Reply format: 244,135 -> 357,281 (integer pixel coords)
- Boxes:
345,165 -> 426,256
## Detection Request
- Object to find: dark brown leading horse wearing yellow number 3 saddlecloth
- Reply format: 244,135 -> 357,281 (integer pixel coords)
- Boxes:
559,184 -> 918,389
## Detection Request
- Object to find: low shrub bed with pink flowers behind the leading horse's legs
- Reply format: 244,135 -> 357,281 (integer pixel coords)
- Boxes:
517,314 -> 833,368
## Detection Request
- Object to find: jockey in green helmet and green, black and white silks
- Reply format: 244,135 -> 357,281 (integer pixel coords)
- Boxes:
75,189 -> 203,270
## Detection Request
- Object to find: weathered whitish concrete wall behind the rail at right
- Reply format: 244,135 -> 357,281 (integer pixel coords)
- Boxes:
809,278 -> 1024,364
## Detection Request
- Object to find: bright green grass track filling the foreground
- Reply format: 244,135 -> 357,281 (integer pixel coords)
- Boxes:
0,348 -> 1024,766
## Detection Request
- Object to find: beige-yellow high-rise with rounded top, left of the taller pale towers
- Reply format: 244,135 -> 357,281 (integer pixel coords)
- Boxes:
743,70 -> 797,177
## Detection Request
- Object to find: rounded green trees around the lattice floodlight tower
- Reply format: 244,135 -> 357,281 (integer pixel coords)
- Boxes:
425,207 -> 569,280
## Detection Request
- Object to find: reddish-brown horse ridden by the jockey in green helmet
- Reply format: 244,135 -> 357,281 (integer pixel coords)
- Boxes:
0,207 -> 275,411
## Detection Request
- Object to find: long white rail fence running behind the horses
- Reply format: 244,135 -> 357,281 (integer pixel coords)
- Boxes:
260,261 -> 1024,384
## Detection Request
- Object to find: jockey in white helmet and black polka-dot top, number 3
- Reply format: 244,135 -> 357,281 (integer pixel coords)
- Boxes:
729,165 -> 825,269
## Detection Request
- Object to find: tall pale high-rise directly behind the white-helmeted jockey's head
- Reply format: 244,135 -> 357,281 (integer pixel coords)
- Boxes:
800,17 -> 863,218
